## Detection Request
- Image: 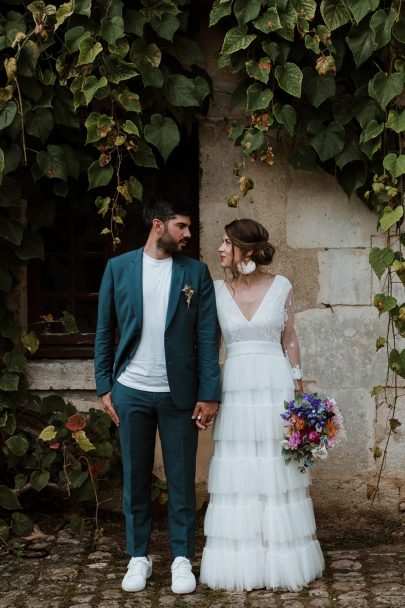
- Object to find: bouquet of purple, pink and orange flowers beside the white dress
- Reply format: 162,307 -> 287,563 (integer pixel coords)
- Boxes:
280,393 -> 345,472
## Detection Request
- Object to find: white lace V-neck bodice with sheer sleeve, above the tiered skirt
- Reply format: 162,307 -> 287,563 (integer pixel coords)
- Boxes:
214,274 -> 302,379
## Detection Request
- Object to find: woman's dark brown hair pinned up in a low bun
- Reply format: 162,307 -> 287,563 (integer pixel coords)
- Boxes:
225,218 -> 275,272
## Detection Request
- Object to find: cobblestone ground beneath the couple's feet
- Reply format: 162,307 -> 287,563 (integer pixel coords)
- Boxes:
0,504 -> 405,608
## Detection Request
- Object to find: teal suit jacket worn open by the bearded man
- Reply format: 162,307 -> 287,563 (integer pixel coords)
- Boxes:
94,248 -> 220,409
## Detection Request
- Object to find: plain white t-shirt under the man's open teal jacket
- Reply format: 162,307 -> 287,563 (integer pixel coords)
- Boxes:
118,253 -> 173,393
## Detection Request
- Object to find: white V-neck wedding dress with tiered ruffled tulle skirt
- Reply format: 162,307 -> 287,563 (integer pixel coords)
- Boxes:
200,275 -> 324,591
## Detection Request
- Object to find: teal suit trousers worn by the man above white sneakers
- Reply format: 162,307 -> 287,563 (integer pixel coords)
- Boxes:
111,382 -> 198,558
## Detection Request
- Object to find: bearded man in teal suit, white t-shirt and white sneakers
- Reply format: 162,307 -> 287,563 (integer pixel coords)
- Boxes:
95,199 -> 220,593
